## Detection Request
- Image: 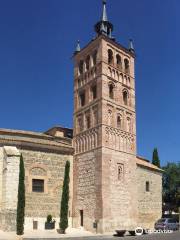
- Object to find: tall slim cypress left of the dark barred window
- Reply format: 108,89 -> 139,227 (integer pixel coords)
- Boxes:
16,154 -> 25,235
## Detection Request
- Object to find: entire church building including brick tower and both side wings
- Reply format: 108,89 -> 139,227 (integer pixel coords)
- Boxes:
0,1 -> 162,233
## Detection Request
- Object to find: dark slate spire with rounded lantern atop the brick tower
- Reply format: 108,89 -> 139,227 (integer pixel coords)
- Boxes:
94,0 -> 113,38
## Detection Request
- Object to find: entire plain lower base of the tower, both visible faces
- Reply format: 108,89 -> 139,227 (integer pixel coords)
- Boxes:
73,148 -> 137,233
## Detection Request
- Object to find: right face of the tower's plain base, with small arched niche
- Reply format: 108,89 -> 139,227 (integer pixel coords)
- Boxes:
102,148 -> 138,232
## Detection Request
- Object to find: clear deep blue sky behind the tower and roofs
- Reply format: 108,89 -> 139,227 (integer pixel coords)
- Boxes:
0,0 -> 180,164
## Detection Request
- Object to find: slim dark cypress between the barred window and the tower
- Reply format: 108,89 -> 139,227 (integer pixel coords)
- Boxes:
59,161 -> 70,233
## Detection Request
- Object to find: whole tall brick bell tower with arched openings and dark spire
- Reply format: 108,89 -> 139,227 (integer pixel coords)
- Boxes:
73,1 -> 137,233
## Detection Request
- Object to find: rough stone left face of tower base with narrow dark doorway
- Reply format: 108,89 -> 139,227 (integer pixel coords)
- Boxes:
73,149 -> 102,232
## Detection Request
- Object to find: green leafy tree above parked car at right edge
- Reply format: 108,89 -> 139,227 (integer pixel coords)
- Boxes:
163,162 -> 180,211
